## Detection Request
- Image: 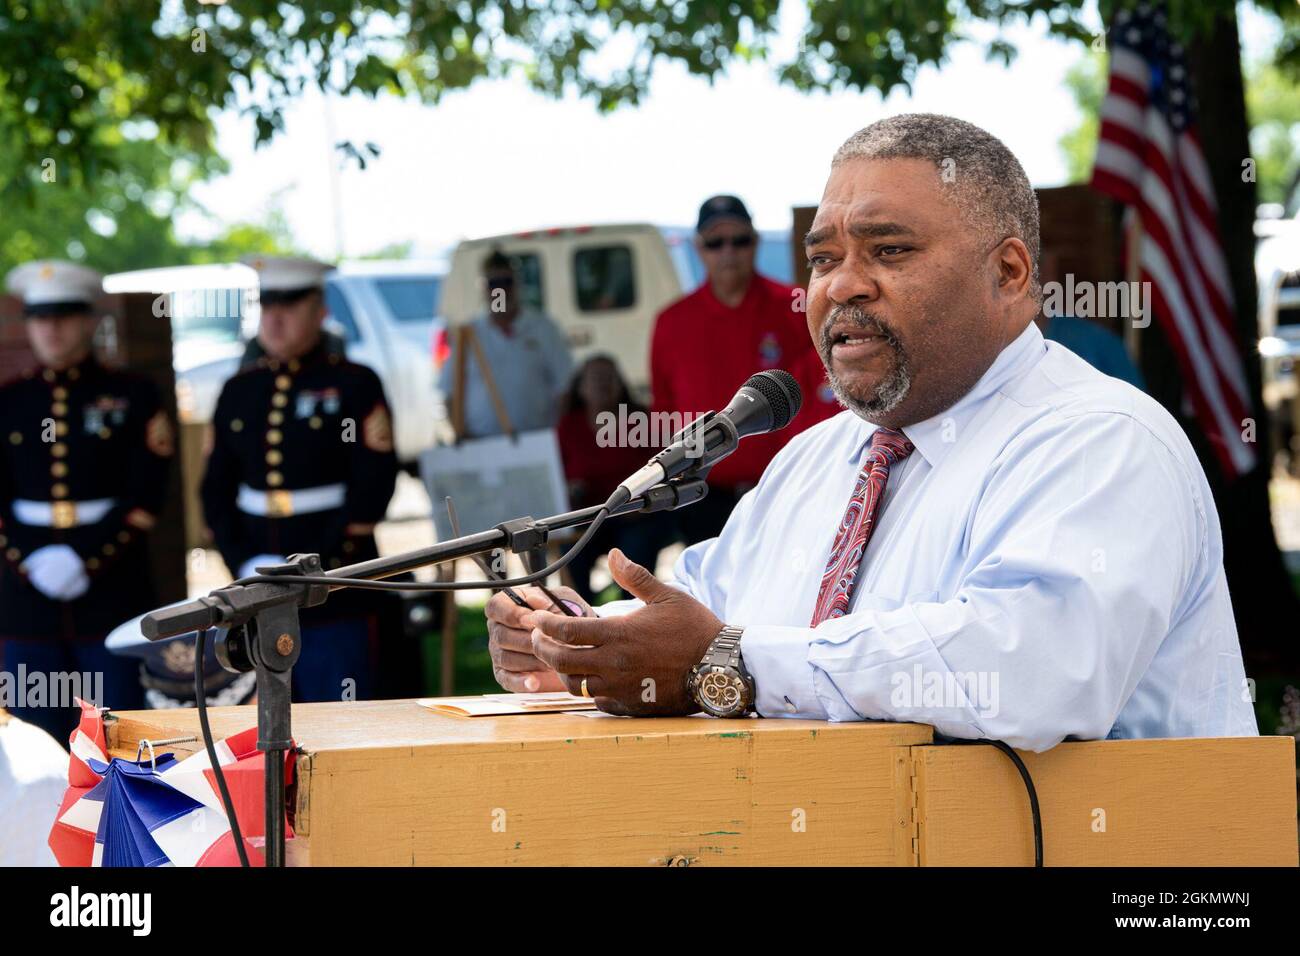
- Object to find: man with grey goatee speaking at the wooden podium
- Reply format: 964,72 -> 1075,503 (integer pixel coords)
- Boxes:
488,114 -> 1257,750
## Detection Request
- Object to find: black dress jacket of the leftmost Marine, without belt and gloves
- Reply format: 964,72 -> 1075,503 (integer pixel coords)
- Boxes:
0,358 -> 176,639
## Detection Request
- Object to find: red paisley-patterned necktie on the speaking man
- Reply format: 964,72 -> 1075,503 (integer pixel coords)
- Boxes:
811,428 -> 913,627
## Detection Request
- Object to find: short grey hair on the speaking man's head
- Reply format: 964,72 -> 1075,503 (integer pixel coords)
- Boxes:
831,113 -> 1043,300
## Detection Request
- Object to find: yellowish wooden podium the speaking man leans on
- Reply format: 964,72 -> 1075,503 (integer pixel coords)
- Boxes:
108,701 -> 1297,866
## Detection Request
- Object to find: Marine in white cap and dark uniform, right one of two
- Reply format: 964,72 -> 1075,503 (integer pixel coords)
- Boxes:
200,256 -> 398,701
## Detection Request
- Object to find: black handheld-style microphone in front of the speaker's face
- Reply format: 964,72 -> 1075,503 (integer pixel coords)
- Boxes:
615,368 -> 803,503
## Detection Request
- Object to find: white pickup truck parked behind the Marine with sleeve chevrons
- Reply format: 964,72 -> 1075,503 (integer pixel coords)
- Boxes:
104,260 -> 446,464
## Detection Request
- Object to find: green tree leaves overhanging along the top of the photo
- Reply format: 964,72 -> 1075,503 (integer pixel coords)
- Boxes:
0,0 -> 1300,195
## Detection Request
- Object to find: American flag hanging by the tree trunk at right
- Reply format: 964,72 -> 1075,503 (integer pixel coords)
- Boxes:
1092,4 -> 1255,477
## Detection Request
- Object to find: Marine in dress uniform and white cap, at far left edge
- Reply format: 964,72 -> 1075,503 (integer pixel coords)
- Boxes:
0,261 -> 174,739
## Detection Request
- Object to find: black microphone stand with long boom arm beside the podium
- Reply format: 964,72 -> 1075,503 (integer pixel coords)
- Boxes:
140,473 -> 709,866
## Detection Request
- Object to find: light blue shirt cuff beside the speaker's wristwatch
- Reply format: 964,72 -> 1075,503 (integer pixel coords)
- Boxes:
740,624 -> 862,721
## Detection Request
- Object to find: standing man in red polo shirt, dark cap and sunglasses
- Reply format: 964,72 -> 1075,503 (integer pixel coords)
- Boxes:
650,195 -> 841,544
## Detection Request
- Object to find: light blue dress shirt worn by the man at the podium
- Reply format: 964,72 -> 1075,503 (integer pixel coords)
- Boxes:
598,324 -> 1258,750
